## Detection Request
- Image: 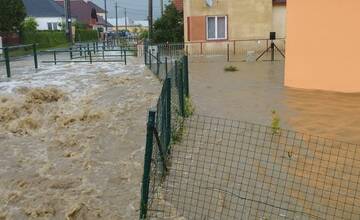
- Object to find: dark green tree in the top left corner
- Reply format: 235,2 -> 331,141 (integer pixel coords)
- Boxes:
0,0 -> 26,32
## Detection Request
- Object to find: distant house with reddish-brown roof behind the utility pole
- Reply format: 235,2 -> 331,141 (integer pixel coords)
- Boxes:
55,0 -> 111,29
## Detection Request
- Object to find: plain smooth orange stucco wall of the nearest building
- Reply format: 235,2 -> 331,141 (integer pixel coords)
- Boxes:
285,0 -> 360,92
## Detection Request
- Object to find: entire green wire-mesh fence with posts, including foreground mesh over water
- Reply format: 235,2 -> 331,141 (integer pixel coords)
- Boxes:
140,43 -> 360,220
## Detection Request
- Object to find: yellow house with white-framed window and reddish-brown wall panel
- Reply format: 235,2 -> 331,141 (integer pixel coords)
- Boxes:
183,0 -> 286,42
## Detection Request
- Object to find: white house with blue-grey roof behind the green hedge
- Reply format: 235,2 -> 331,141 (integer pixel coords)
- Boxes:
23,0 -> 65,30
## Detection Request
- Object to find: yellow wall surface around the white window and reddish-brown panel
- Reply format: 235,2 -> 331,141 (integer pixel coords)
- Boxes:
184,0 -> 272,41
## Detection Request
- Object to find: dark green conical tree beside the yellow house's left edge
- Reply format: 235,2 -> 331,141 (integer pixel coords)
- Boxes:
153,3 -> 184,43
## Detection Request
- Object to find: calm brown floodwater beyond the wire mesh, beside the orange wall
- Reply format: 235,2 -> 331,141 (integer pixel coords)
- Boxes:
190,58 -> 360,144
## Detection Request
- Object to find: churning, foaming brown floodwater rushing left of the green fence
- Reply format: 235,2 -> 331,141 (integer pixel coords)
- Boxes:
0,58 -> 160,220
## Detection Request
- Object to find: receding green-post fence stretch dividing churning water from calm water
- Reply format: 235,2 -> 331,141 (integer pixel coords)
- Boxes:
140,45 -> 191,219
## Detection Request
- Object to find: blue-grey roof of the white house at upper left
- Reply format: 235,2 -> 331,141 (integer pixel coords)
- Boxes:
22,0 -> 64,17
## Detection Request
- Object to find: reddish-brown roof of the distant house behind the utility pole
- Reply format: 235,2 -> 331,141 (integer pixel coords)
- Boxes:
55,0 -> 111,26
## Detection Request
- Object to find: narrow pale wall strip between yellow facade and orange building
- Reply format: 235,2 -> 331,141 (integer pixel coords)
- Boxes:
272,5 -> 286,38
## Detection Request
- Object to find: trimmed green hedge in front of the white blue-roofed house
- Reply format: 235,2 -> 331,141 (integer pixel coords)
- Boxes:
21,31 -> 67,48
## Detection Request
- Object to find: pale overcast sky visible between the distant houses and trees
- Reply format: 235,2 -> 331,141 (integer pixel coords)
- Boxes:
92,0 -> 169,19
